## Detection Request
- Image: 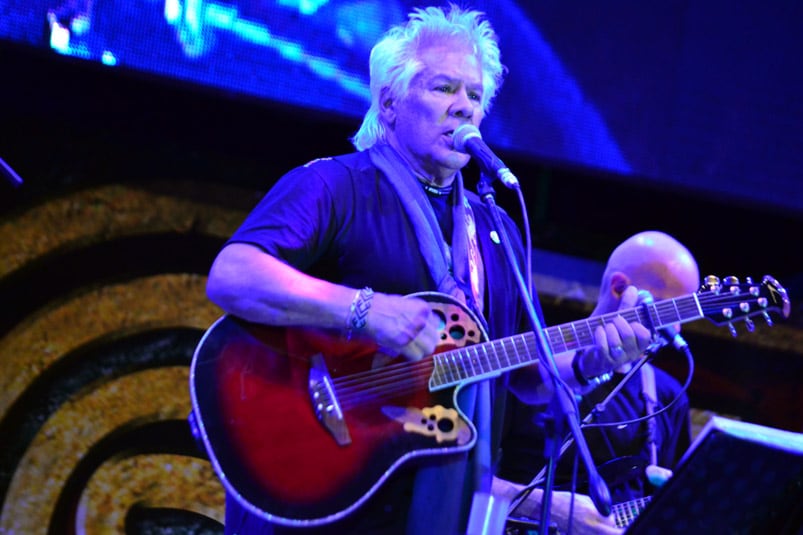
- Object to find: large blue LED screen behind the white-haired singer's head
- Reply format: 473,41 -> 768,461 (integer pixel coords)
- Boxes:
0,0 -> 803,211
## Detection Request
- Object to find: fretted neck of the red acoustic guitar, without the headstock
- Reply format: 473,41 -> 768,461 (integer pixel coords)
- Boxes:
429,294 -> 704,391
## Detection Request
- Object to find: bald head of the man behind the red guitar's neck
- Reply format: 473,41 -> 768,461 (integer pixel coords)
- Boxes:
600,230 -> 700,306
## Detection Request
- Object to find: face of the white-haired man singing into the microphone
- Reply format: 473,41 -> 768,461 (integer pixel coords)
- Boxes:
383,44 -> 482,185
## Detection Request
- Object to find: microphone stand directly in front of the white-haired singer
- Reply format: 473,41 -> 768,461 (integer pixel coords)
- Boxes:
477,172 -> 611,533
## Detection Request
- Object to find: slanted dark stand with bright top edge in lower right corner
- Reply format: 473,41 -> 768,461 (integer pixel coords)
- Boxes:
627,416 -> 803,535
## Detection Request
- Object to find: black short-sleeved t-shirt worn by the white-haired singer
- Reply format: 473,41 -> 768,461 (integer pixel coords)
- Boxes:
228,151 -> 526,339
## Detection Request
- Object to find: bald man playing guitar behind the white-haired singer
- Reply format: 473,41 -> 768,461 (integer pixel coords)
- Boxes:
494,231 -> 700,534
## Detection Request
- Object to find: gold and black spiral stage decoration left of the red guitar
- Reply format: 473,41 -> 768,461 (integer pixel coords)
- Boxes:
0,183 -> 253,534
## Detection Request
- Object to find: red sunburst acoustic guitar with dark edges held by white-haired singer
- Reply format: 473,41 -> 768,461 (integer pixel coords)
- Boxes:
190,276 -> 791,527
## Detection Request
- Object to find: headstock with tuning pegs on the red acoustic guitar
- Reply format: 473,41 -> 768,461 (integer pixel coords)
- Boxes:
697,275 -> 792,336
